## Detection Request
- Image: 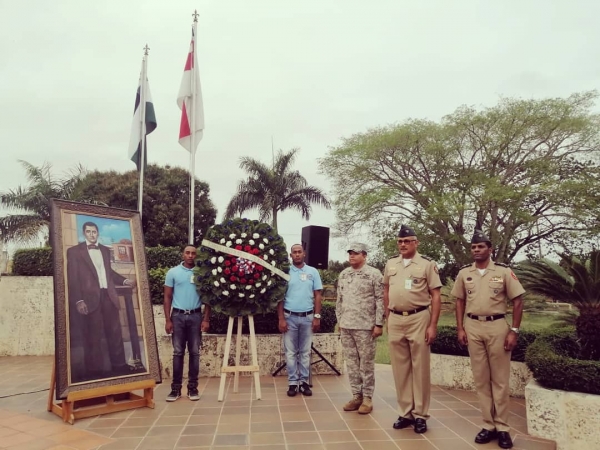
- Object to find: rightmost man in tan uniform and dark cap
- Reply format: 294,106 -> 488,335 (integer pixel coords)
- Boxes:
452,230 -> 525,448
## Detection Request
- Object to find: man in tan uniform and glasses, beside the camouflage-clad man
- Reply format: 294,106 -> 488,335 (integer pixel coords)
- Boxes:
383,225 -> 442,433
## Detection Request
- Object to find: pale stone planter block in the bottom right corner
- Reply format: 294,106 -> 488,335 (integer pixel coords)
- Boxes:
525,380 -> 600,450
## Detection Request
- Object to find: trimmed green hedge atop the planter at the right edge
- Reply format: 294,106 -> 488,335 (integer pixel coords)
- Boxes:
525,328 -> 600,395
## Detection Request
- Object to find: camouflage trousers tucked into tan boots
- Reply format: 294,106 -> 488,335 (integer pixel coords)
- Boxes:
340,328 -> 376,397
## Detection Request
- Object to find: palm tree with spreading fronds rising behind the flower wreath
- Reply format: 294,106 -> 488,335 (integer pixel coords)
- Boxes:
225,149 -> 331,229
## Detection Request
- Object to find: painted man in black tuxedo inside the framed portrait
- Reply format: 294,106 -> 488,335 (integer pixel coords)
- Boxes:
67,222 -> 135,381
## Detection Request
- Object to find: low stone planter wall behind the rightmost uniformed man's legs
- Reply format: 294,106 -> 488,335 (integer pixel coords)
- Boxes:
431,353 -> 532,398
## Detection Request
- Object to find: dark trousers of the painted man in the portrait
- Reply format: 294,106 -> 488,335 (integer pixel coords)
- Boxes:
77,289 -> 127,379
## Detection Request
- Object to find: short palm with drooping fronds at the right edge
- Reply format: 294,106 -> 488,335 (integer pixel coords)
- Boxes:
515,250 -> 600,360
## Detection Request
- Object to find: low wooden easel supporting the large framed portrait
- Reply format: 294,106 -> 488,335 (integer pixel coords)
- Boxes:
48,362 -> 156,425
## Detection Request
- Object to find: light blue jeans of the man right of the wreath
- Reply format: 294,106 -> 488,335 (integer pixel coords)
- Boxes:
283,313 -> 313,384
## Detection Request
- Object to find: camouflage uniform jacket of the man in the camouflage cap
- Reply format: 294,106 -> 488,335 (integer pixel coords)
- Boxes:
335,264 -> 383,330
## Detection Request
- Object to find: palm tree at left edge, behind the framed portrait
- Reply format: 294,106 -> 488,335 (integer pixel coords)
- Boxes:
0,161 -> 86,243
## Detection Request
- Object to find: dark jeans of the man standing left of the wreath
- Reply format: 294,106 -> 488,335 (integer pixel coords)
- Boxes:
171,311 -> 202,390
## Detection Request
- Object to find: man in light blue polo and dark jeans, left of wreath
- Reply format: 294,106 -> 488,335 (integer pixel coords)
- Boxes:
164,245 -> 210,402
